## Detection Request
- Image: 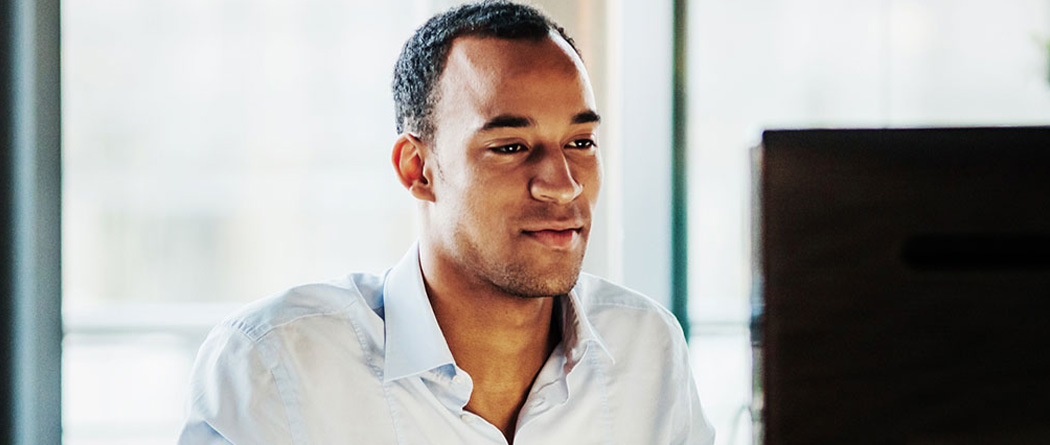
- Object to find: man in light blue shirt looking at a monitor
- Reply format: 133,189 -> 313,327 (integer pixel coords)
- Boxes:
181,2 -> 714,444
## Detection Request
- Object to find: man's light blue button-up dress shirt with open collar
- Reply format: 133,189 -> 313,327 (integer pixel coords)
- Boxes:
179,247 -> 714,445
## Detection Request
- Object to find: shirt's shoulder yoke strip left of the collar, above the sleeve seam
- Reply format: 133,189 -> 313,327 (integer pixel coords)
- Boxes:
221,273 -> 383,340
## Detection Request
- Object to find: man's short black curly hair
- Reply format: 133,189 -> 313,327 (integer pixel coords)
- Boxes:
393,0 -> 580,140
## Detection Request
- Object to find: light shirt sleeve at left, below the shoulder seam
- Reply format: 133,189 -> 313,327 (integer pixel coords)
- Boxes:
179,325 -> 294,445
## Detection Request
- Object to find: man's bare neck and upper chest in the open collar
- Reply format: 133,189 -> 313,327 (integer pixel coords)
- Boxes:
421,246 -> 561,442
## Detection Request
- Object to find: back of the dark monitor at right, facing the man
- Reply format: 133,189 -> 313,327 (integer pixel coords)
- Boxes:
755,128 -> 1050,445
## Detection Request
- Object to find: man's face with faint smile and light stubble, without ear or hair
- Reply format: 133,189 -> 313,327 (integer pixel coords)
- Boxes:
425,36 -> 602,297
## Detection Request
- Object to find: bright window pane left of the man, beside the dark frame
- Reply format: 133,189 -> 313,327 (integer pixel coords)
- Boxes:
62,0 -> 429,444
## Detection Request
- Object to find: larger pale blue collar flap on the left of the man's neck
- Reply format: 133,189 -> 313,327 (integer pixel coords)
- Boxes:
383,243 -> 455,382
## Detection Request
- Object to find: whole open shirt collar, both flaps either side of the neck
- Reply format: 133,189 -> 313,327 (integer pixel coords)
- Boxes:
383,242 -> 615,382
